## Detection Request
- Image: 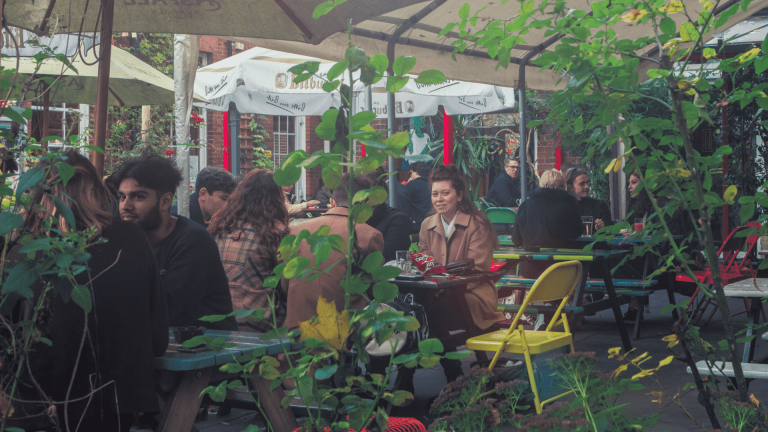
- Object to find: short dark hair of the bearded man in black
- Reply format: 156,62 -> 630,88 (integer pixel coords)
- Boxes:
111,153 -> 181,193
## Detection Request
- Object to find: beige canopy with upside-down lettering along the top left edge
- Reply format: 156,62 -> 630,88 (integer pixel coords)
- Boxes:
5,0 -> 419,44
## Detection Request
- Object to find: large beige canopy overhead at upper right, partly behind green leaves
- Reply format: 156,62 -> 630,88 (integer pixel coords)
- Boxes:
230,0 -> 768,90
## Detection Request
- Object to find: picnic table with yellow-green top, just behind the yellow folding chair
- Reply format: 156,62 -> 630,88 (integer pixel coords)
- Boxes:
493,248 -> 632,351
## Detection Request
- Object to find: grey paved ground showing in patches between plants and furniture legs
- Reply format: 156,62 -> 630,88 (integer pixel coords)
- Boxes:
132,292 -> 768,432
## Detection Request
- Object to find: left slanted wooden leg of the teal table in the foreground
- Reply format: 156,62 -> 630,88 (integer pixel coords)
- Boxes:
157,368 -> 211,432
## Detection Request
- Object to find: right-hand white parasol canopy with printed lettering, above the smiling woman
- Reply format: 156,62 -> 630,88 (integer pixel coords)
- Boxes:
355,76 -> 515,119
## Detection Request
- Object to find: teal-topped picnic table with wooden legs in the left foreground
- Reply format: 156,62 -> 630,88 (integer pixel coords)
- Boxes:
154,330 -> 299,432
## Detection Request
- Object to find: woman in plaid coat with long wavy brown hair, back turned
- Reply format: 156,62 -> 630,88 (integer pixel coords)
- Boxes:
208,170 -> 288,332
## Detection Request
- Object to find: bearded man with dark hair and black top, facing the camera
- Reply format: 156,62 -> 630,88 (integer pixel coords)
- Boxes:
112,154 -> 238,330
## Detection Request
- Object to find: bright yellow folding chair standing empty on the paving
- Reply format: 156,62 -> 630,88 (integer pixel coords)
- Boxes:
467,261 -> 581,414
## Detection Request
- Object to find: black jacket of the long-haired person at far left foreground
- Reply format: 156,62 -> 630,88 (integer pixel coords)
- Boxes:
27,220 -> 168,424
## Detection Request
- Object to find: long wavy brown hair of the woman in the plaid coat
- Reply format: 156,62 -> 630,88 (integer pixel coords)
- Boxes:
208,169 -> 288,246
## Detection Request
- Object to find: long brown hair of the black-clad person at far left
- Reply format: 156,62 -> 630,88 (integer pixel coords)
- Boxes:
24,150 -> 114,233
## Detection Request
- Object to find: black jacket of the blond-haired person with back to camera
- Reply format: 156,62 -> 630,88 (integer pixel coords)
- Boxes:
512,188 -> 583,248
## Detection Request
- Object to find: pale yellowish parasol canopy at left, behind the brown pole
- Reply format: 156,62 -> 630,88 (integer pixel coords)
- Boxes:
19,42 -> 205,107
